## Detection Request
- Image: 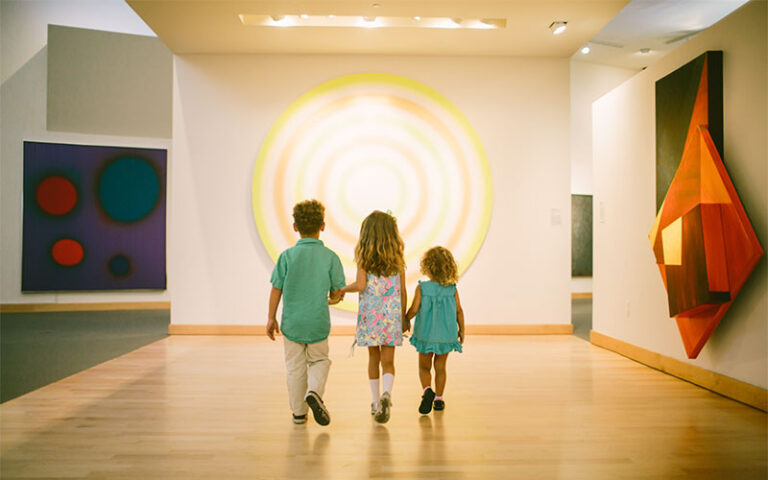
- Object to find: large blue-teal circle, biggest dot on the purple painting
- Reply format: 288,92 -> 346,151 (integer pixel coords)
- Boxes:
99,157 -> 160,223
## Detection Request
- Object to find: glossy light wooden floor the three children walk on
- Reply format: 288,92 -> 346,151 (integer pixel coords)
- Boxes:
0,335 -> 768,480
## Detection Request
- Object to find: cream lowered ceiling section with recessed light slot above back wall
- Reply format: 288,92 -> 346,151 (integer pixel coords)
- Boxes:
126,0 -> 629,57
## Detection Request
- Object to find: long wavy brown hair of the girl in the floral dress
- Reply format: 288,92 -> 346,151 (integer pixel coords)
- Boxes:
355,210 -> 405,277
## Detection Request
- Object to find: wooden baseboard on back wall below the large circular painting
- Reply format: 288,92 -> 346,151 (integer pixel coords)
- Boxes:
168,323 -> 573,335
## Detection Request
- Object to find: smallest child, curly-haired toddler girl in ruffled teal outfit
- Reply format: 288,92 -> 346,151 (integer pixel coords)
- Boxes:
404,247 -> 464,414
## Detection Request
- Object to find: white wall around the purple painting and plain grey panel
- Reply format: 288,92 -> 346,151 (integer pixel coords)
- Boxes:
0,0 -> 172,304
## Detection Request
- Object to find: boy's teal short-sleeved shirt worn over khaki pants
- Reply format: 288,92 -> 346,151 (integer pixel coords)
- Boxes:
270,238 -> 344,343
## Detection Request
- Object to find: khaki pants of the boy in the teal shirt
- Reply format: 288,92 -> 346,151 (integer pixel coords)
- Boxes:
283,337 -> 331,415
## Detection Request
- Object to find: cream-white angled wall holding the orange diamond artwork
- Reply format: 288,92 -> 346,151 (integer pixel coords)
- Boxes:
592,1 -> 768,388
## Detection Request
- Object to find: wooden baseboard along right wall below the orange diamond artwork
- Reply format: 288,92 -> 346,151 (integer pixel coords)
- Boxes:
589,330 -> 768,412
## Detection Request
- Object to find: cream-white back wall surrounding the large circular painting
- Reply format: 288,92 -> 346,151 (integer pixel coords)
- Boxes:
168,55 -> 570,325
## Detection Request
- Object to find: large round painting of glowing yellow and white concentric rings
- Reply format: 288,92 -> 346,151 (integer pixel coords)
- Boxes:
252,74 -> 493,311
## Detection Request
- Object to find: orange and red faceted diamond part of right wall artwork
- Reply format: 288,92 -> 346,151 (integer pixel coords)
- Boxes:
649,52 -> 763,358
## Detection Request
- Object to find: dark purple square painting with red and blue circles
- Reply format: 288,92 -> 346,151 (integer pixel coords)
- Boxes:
21,142 -> 167,292
